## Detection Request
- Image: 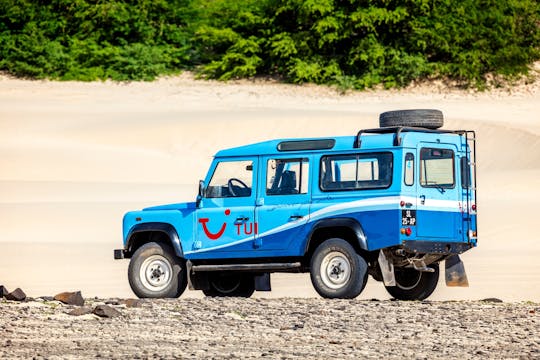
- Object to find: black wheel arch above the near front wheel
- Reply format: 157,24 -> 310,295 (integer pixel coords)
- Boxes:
125,222 -> 184,258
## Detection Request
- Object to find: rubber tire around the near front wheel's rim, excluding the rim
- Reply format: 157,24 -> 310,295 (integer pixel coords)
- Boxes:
128,242 -> 187,298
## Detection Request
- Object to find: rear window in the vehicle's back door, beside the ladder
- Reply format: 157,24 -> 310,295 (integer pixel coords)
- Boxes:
420,148 -> 455,188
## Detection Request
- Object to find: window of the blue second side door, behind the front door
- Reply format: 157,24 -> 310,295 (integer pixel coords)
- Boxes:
266,158 -> 309,195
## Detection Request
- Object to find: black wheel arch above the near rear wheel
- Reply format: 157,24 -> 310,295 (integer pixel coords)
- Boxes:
304,218 -> 368,258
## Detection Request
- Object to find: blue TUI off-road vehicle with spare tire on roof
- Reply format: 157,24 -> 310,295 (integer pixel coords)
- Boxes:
114,110 -> 477,300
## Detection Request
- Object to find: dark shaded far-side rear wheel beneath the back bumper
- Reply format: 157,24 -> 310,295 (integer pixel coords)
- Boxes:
386,264 -> 439,300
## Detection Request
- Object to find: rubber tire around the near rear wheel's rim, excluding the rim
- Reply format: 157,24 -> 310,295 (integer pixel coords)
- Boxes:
310,238 -> 367,299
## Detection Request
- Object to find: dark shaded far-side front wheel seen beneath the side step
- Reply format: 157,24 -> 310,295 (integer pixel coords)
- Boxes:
203,273 -> 255,298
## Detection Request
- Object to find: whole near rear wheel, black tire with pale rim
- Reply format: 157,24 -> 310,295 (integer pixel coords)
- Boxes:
310,238 -> 368,299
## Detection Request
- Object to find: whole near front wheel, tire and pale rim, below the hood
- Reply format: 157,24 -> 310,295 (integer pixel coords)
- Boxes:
128,242 -> 187,298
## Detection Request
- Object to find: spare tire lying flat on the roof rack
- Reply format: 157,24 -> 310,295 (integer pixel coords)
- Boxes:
379,109 -> 444,129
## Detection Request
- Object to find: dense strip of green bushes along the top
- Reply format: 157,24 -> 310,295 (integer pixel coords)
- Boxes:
0,0 -> 540,89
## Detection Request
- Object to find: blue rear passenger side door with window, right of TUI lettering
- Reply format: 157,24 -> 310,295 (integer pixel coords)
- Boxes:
255,156 -> 311,255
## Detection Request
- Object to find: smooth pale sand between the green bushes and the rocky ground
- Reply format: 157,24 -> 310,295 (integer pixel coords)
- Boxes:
0,75 -> 540,301
